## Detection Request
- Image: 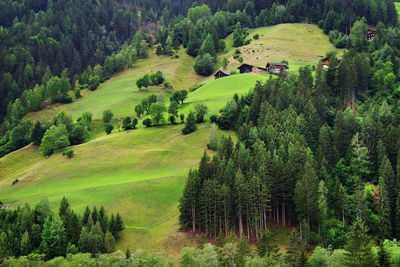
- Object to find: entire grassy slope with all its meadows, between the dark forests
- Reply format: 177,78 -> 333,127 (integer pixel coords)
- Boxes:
0,24 -> 340,253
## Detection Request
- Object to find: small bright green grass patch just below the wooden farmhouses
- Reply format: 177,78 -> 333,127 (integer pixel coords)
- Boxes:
181,73 -> 271,117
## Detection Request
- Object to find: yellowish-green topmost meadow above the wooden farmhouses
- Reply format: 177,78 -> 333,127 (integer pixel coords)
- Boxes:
222,24 -> 341,72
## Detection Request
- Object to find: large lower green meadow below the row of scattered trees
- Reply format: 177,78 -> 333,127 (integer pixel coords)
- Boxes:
0,124 -> 216,253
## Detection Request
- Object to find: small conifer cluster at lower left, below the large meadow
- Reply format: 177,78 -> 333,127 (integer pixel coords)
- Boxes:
0,198 -> 124,260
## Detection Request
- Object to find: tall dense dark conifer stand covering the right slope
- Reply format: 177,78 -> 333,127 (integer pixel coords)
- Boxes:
180,20 -> 400,256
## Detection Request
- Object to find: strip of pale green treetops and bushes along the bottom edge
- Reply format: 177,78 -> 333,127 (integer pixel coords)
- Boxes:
3,223 -> 400,267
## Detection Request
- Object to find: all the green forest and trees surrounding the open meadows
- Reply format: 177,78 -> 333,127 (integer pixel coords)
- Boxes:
0,0 -> 400,266
